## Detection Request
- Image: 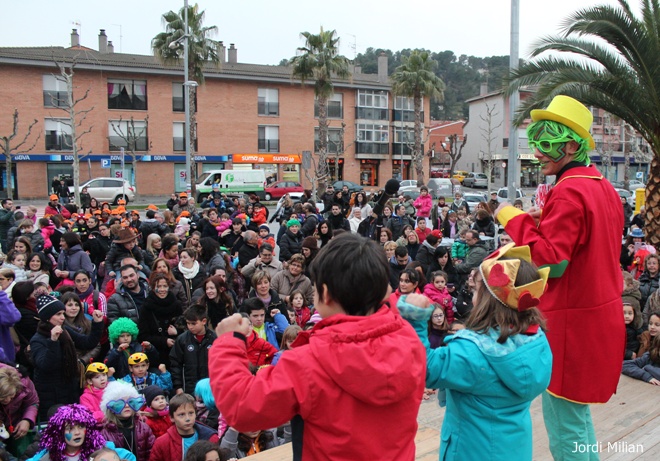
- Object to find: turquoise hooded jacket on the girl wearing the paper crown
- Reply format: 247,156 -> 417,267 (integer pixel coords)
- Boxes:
400,301 -> 552,461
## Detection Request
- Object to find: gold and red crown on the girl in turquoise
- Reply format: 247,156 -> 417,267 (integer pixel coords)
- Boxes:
479,243 -> 550,312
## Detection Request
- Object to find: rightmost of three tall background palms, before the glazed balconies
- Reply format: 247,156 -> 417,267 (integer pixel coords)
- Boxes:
390,50 -> 445,186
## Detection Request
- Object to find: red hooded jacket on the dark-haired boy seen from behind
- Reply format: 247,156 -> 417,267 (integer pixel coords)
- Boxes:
209,306 -> 426,461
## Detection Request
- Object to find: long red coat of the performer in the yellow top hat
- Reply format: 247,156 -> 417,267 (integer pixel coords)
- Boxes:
497,167 -> 626,403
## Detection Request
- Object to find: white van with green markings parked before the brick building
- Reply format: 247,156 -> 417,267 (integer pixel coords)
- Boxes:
196,170 -> 266,199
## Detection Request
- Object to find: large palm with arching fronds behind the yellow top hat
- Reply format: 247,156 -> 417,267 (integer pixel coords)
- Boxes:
507,0 -> 660,246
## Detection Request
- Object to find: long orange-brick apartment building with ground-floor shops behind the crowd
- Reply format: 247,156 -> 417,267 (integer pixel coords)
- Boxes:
0,29 -> 429,198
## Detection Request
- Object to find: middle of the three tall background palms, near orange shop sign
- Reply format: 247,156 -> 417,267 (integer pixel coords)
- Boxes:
289,27 -> 351,191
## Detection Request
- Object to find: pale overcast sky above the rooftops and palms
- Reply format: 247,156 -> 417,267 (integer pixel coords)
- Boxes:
5,0 -> 620,64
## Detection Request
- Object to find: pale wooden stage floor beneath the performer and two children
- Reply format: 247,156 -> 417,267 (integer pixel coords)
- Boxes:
250,376 -> 660,461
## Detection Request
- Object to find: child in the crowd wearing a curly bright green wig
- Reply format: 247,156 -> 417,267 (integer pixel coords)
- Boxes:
105,317 -> 160,379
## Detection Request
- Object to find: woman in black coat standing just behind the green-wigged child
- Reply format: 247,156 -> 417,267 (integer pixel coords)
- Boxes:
138,273 -> 183,368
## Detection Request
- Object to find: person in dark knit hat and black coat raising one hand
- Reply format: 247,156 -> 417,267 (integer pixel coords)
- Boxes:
30,295 -> 103,420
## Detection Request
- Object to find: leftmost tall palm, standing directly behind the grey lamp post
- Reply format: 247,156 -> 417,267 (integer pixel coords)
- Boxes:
151,4 -> 220,197
